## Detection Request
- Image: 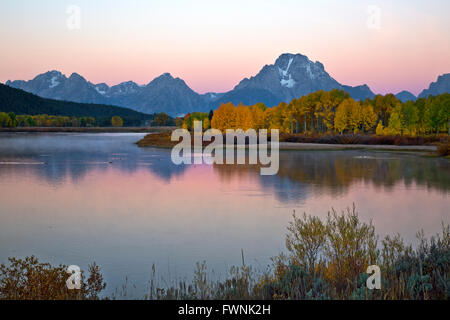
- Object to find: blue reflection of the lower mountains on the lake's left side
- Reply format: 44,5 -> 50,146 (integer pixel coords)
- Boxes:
0,135 -> 186,184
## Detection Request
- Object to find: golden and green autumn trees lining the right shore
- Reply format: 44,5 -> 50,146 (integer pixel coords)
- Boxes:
175,89 -> 450,136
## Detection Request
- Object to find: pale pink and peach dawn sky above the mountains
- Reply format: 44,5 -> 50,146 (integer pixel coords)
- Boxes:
0,0 -> 450,94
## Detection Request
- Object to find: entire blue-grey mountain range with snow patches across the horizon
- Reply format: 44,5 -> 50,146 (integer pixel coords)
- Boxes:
6,53 -> 450,116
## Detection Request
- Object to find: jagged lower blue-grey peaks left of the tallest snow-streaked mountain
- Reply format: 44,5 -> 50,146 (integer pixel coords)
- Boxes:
6,71 -> 207,115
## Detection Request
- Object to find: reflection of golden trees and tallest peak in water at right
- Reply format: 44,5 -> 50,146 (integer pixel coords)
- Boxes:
214,151 -> 450,201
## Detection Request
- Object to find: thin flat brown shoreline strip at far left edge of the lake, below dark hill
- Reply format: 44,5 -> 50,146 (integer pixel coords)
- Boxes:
0,127 -> 173,133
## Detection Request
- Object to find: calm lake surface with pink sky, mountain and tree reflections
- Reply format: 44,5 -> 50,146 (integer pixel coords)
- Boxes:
0,133 -> 450,297
